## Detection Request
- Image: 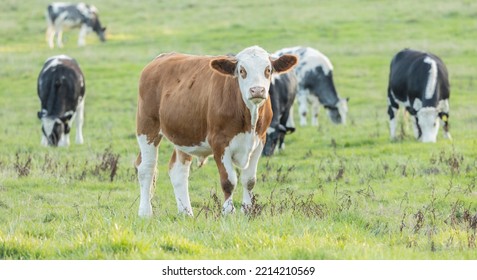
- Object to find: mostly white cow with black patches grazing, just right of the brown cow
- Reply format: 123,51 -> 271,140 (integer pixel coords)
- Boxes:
275,47 -> 348,126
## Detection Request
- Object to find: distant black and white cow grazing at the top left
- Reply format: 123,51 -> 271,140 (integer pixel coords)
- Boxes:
46,3 -> 106,48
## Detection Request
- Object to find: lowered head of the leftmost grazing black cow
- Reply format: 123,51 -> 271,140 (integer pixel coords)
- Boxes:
38,110 -> 72,147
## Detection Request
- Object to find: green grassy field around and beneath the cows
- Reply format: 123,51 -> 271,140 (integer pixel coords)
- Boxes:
0,0 -> 477,259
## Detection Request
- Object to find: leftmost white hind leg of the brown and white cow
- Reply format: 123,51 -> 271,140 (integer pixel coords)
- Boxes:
136,135 -> 157,217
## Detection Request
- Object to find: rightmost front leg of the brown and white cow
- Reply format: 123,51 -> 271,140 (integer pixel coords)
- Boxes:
240,142 -> 264,213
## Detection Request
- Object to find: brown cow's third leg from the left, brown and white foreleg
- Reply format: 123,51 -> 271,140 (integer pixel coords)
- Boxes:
214,151 -> 237,214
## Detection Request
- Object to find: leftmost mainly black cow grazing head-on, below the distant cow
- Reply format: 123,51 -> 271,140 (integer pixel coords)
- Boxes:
38,55 -> 85,146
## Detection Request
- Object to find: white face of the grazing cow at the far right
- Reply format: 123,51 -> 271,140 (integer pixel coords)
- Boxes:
416,107 -> 439,143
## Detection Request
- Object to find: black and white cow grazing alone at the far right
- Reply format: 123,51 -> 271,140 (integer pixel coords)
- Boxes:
388,49 -> 451,142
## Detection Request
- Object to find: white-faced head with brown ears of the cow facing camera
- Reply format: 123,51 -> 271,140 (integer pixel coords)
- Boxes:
210,46 -> 298,108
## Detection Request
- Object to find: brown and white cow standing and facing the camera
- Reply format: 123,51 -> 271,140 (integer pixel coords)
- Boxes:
136,46 -> 297,216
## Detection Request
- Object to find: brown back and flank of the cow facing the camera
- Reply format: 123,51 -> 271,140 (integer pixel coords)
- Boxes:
137,53 -> 245,146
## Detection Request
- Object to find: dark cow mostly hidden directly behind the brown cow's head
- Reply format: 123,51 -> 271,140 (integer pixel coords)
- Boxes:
263,71 -> 297,156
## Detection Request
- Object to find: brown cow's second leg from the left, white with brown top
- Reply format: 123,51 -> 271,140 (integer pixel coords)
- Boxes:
169,149 -> 194,216
